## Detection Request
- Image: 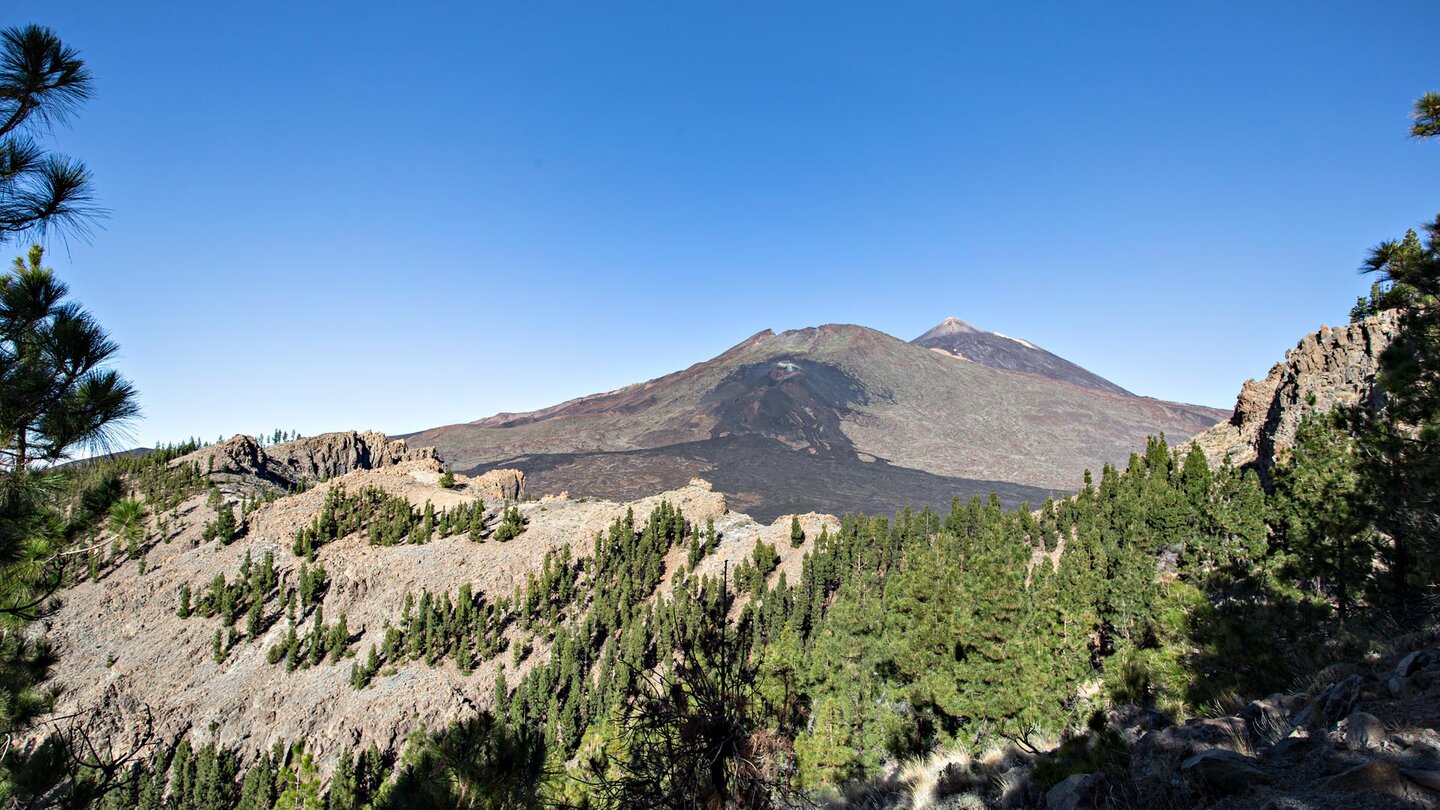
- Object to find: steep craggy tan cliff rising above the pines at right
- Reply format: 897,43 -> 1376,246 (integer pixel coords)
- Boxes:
1191,311 -> 1400,481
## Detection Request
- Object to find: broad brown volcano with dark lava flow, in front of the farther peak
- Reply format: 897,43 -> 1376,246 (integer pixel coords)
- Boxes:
408,324 -> 1230,520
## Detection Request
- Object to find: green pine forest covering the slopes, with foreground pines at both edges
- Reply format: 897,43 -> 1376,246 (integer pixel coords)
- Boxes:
0,27 -> 1440,810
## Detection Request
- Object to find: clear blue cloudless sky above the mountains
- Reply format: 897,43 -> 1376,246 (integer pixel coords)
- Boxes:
0,0 -> 1440,444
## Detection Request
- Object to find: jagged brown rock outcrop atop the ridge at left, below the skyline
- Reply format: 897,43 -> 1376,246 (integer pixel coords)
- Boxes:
173,431 -> 440,497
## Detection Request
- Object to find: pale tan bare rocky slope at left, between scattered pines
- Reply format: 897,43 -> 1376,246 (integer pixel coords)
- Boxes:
30,434 -> 838,774
